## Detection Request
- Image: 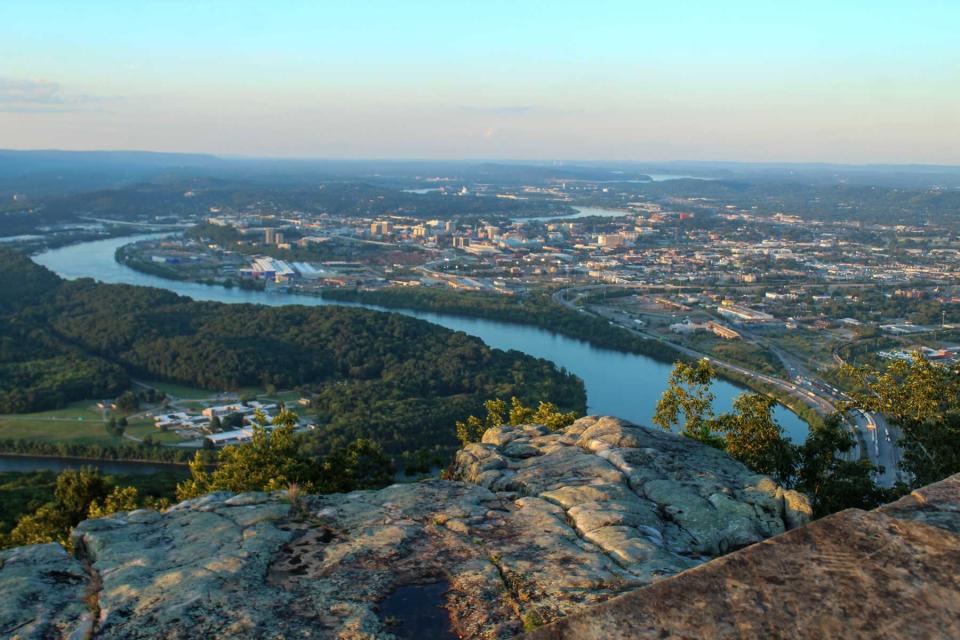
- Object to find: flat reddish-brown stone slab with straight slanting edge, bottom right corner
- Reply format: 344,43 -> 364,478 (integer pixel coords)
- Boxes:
529,475 -> 960,640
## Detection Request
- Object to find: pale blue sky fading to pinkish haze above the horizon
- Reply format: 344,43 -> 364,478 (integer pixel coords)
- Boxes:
0,0 -> 960,164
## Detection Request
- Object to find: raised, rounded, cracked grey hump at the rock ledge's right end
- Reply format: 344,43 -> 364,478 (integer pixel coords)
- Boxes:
456,417 -> 810,564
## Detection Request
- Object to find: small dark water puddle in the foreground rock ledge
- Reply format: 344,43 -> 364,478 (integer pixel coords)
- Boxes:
379,582 -> 457,640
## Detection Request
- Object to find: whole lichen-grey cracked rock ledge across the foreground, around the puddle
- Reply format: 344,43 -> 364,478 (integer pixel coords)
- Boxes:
0,417 -> 810,639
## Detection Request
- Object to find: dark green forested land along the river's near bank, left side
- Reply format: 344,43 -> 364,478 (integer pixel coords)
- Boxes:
0,250 -> 585,454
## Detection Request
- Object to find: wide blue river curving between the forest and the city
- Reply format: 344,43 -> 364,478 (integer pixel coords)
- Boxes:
34,234 -> 807,442
